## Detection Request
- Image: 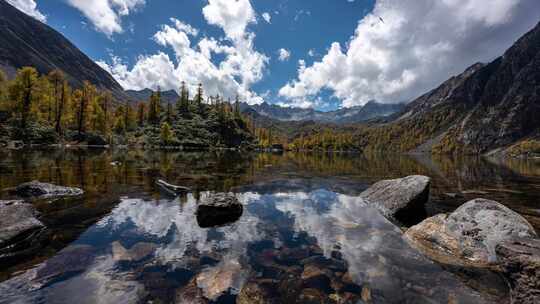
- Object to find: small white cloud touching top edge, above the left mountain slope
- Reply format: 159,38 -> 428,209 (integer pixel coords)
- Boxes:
67,0 -> 146,37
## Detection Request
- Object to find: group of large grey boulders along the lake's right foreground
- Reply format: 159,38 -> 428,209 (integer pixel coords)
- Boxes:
360,176 -> 540,303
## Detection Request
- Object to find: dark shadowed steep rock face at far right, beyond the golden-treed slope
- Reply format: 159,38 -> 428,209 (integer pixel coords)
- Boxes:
443,23 -> 540,152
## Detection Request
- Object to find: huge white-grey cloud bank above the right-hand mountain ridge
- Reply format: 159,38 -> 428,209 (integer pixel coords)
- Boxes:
279,0 -> 540,107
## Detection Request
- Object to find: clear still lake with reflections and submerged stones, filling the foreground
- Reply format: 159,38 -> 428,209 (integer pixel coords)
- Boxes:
0,149 -> 540,303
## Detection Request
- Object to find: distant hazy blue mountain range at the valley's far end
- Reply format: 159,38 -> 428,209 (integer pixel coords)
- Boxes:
242,100 -> 404,124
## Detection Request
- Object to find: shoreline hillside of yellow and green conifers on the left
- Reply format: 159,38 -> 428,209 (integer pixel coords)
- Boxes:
0,67 -> 254,148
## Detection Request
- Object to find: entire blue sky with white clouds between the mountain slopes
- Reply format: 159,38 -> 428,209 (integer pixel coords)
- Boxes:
8,0 -> 540,110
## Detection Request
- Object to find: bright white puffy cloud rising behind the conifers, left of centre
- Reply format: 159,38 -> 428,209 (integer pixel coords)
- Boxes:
98,0 -> 269,104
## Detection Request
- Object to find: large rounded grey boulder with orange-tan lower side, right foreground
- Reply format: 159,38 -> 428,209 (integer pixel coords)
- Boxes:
405,199 -> 536,267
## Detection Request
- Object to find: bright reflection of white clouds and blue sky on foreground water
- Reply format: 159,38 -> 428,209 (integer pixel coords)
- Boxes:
0,185 -> 506,303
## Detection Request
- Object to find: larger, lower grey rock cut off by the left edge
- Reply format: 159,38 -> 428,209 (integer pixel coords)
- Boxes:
0,201 -> 45,261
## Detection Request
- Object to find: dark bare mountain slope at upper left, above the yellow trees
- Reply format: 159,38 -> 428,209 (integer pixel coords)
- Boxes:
0,0 -> 126,99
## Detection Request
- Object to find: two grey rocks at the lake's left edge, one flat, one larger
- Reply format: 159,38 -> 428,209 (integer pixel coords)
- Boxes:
0,181 -> 83,264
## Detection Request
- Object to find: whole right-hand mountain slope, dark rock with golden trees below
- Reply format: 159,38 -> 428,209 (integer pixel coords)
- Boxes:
357,24 -> 540,154
